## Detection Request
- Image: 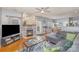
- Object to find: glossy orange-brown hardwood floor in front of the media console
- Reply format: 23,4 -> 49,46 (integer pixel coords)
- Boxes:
0,37 -> 33,52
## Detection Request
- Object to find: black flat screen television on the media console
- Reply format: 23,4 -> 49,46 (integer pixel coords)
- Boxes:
2,25 -> 20,37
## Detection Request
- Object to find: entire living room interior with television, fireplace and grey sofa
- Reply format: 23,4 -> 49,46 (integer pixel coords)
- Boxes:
0,7 -> 79,52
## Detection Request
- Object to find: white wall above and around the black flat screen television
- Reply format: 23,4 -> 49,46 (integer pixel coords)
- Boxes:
0,8 -> 22,46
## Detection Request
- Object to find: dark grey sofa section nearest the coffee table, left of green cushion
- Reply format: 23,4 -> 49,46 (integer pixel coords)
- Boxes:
47,32 -> 66,44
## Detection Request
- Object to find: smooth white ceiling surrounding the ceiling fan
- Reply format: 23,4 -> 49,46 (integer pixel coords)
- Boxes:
3,7 -> 79,18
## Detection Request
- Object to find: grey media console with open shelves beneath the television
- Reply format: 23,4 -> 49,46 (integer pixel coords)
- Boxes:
1,33 -> 21,47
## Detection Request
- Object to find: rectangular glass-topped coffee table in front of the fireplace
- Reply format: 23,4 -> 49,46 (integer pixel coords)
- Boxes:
24,36 -> 45,52
